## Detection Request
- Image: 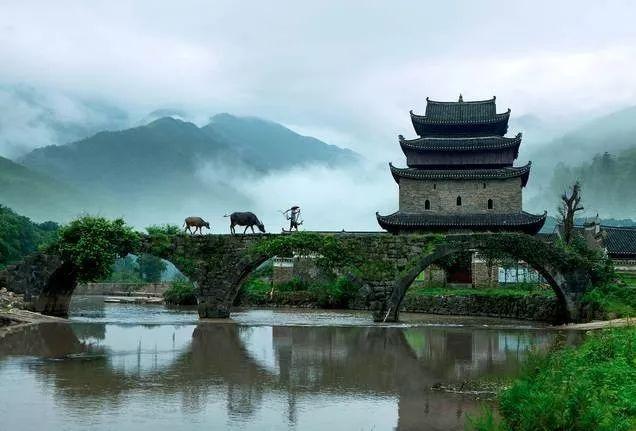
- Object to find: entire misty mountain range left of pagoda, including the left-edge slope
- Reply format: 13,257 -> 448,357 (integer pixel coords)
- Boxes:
0,114 -> 359,222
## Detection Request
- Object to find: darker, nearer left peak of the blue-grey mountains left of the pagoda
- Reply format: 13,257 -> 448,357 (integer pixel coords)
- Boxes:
20,117 -> 226,197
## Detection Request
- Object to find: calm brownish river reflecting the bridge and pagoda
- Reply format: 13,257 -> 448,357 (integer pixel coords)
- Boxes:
0,297 -> 581,431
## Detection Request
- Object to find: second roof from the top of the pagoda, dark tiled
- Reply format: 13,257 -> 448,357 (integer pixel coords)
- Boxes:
398,133 -> 522,155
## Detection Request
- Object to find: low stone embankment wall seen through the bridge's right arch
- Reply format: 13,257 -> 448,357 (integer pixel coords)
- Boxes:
402,295 -> 563,323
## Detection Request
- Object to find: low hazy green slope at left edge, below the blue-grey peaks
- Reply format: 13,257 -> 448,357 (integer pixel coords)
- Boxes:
0,157 -> 86,221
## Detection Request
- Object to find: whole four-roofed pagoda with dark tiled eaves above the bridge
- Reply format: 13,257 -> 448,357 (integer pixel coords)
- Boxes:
376,95 -> 546,234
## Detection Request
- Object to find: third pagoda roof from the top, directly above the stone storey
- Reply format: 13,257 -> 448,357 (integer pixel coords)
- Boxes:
389,162 -> 532,187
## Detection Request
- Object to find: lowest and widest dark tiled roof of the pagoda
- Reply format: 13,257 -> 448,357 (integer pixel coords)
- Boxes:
376,211 -> 547,235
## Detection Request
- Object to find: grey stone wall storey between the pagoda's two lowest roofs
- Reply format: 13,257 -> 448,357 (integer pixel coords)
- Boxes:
399,178 -> 522,214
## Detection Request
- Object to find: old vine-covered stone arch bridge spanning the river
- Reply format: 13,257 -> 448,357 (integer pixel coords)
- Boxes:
0,232 -> 591,322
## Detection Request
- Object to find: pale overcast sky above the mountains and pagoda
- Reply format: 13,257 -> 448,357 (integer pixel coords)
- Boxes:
0,0 -> 636,159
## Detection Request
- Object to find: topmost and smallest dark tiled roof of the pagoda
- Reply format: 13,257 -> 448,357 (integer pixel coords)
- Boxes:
410,95 -> 510,136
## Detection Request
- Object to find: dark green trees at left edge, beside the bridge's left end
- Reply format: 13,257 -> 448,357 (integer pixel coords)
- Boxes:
0,205 -> 58,269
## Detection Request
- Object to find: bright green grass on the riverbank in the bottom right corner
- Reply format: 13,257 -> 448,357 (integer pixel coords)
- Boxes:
470,326 -> 636,431
